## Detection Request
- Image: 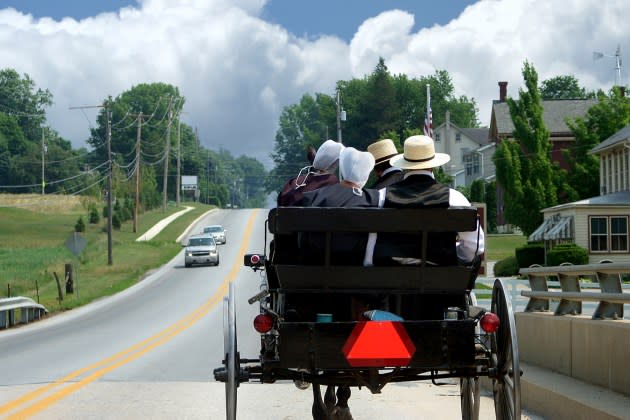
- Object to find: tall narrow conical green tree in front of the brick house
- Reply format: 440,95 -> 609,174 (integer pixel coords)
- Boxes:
492,61 -> 557,235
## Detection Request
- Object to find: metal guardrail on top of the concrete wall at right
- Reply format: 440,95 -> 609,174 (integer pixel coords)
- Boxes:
520,262 -> 630,319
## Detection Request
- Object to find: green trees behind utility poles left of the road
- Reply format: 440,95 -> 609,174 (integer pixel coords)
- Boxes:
0,69 -> 267,210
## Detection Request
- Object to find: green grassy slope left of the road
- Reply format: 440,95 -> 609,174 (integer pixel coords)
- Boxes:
0,197 -> 213,312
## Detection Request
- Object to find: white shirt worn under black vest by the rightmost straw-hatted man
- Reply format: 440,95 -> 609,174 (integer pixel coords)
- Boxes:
363,169 -> 485,266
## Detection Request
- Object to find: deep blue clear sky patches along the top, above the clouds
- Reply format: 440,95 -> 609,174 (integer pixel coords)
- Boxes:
0,0 -> 476,41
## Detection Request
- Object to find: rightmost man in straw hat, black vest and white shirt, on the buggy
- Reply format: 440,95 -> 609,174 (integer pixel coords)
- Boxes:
373,136 -> 484,265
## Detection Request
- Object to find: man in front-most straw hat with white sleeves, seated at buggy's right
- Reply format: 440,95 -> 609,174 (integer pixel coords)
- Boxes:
374,135 -> 485,264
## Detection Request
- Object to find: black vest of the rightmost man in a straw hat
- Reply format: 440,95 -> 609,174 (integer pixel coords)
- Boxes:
374,174 -> 457,265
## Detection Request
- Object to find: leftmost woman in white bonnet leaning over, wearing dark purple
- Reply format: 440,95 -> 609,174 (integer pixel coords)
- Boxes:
277,140 -> 344,207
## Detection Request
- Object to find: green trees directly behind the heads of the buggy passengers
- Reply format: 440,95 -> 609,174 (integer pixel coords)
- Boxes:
266,58 -> 479,192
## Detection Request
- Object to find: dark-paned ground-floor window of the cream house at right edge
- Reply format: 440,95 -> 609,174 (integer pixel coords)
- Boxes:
590,216 -> 628,252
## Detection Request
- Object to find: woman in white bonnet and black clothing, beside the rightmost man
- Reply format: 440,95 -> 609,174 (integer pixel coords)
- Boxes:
299,147 -> 379,265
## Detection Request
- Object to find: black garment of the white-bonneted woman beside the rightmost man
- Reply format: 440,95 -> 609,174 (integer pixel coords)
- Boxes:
299,184 -> 378,265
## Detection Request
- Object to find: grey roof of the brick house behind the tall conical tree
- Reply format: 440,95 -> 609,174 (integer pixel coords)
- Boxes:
492,99 -> 597,136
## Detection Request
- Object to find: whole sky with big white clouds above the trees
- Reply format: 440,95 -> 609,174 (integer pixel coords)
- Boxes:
0,0 -> 630,166
